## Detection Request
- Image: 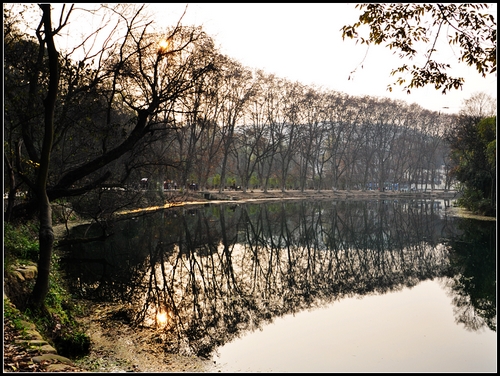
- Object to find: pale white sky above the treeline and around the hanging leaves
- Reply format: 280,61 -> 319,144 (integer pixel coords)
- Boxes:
149,3 -> 497,113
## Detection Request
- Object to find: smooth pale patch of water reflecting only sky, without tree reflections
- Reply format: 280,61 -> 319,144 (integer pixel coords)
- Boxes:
209,281 -> 497,372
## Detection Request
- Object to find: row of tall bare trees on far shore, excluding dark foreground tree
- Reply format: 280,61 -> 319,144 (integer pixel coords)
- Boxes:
144,75 -> 453,191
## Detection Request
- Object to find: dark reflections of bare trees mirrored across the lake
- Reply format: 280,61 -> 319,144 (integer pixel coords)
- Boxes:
63,200 -> 496,356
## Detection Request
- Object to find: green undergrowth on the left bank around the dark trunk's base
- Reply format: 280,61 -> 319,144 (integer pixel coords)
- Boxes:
4,222 -> 90,357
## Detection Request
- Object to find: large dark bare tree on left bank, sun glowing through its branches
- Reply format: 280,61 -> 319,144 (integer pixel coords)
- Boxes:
3,4 -> 214,306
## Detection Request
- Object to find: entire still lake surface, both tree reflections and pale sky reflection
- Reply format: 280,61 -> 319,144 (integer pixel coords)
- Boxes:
63,200 -> 497,372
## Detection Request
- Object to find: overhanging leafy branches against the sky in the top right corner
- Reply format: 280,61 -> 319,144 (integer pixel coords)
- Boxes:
341,3 -> 497,94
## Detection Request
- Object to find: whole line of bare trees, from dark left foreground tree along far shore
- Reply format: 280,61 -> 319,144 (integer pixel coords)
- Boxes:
4,4 -> 496,305
